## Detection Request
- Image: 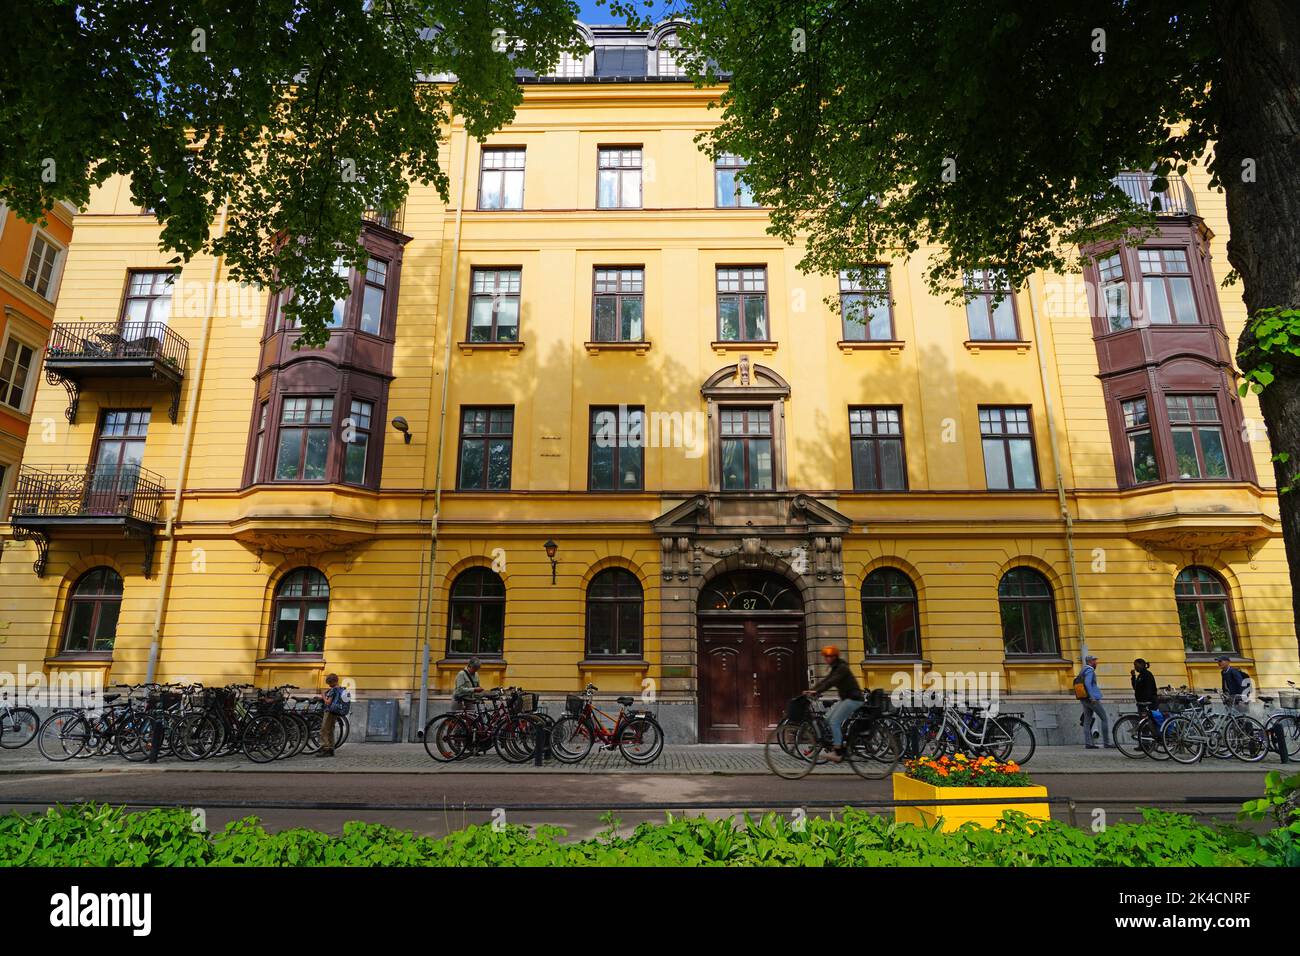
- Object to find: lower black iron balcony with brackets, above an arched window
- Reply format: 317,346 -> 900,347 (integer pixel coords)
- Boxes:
9,464 -> 164,578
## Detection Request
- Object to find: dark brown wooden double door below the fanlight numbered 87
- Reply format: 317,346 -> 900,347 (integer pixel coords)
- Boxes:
699,613 -> 807,744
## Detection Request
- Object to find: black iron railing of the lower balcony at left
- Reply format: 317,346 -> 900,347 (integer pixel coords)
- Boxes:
9,464 -> 164,524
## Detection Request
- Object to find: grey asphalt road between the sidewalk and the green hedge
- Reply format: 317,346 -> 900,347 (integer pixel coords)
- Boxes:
0,769 -> 1265,838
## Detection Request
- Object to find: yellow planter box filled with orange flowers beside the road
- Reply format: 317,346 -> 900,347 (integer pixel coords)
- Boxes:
893,753 -> 1052,832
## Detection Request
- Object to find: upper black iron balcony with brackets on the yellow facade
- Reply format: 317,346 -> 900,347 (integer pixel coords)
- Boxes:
46,323 -> 190,425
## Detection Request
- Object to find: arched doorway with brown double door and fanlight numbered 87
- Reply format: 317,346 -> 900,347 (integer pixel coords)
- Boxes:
697,571 -> 806,744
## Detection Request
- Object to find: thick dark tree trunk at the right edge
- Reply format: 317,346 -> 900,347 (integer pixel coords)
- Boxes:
1212,0 -> 1300,650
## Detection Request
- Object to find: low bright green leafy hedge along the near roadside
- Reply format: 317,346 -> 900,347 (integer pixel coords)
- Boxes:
0,804 -> 1300,866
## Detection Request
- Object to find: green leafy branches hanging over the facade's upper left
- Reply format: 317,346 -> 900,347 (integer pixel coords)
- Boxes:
0,0 -> 580,345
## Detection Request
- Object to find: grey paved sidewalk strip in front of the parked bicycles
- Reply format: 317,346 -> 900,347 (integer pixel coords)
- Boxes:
0,743 -> 1300,777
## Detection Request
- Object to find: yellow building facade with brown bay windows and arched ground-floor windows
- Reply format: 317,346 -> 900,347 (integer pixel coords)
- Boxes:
0,20 -> 1300,743
